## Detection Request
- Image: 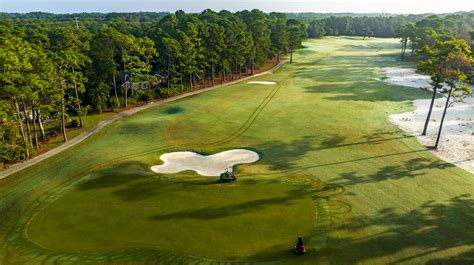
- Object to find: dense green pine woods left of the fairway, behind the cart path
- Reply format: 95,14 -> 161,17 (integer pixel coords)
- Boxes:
0,10 -> 306,163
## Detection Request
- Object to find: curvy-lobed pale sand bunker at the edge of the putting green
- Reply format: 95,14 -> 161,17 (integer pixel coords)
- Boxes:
151,149 -> 260,176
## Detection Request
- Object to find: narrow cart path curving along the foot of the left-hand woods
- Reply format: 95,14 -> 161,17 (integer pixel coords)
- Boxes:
0,61 -> 285,179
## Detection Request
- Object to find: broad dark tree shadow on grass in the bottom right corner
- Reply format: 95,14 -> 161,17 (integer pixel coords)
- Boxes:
320,194 -> 474,264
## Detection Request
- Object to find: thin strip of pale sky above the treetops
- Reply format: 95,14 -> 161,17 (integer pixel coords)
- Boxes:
0,0 -> 474,14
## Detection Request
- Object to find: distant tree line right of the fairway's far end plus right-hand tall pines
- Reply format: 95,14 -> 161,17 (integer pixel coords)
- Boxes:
306,11 -> 474,148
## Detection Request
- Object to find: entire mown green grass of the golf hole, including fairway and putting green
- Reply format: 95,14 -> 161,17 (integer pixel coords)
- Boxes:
0,37 -> 474,264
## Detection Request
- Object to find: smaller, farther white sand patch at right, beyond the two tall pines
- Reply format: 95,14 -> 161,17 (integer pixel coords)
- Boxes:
382,67 -> 431,89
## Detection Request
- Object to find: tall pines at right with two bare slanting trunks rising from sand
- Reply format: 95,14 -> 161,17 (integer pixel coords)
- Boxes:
397,16 -> 474,149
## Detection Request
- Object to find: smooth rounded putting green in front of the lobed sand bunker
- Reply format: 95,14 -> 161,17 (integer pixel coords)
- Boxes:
28,174 -> 315,259
